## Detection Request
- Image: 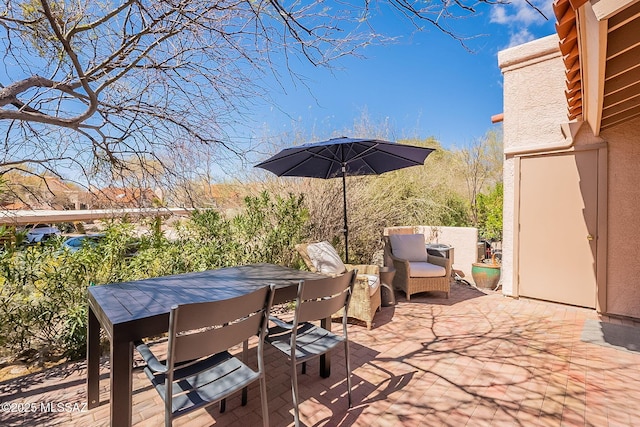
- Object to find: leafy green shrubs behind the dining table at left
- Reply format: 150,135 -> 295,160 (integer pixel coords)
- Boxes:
0,193 -> 308,358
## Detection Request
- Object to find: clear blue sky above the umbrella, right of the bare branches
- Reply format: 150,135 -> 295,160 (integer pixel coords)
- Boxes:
252,0 -> 555,148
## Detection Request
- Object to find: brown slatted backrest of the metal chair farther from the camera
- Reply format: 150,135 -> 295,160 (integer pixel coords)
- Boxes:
294,270 -> 357,326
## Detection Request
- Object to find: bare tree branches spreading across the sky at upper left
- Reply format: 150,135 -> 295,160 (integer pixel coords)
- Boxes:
0,0 -> 516,191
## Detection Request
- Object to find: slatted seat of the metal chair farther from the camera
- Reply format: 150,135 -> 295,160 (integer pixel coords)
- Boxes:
265,323 -> 344,363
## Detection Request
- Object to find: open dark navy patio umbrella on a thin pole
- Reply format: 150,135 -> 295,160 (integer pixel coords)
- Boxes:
256,137 -> 434,262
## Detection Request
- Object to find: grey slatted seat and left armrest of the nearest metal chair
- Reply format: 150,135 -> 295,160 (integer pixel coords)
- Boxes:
144,352 -> 260,416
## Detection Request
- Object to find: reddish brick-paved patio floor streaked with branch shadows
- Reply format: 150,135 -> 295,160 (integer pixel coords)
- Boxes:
0,283 -> 640,426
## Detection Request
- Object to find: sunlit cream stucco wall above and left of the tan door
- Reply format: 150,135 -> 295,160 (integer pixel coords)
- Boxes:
498,35 -> 567,295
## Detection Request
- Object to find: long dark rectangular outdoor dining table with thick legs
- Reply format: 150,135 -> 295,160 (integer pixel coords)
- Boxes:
87,264 -> 331,426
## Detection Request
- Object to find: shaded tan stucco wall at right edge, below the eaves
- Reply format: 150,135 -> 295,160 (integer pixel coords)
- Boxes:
600,117 -> 640,318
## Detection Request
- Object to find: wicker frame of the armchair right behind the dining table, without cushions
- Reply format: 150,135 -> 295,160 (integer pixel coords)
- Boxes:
296,242 -> 382,330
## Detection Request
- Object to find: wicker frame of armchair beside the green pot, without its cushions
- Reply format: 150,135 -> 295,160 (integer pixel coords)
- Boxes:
384,236 -> 451,301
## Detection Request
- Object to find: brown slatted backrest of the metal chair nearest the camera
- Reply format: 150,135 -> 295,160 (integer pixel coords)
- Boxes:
167,285 -> 275,367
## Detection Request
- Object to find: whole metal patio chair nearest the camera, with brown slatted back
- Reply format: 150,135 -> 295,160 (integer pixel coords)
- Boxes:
136,285 -> 275,427
